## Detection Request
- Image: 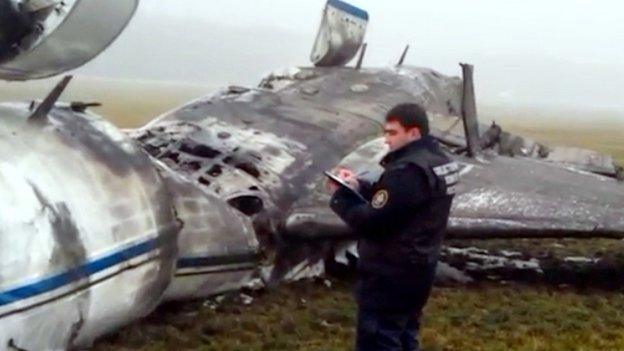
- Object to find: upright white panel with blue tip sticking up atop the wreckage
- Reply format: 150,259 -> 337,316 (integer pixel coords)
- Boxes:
310,0 -> 368,66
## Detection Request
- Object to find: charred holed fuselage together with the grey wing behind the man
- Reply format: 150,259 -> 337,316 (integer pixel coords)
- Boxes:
132,66 -> 624,288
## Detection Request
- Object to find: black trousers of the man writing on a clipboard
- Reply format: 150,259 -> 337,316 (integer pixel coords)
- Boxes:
355,264 -> 436,351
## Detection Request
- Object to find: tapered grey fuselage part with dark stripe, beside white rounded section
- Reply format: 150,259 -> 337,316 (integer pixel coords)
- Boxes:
152,159 -> 259,300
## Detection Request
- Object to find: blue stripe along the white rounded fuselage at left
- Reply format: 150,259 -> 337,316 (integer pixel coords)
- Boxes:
0,238 -> 159,306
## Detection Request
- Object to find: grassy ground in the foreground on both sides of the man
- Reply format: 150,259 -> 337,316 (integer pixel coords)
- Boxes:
95,282 -> 624,351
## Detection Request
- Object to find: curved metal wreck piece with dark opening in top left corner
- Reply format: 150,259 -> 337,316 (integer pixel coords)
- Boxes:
0,0 -> 138,80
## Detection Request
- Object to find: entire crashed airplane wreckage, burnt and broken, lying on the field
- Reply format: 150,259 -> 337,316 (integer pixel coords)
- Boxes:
0,0 -> 624,349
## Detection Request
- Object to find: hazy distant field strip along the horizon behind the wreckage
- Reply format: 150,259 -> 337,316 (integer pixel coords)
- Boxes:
0,75 -> 624,129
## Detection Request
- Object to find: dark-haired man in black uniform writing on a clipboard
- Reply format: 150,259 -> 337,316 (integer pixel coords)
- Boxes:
328,104 -> 458,351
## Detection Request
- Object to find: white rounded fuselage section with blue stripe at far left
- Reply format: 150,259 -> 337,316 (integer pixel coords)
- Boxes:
0,104 -> 179,350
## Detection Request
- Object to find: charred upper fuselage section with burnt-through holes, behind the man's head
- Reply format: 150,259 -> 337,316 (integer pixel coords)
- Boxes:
132,68 -> 460,242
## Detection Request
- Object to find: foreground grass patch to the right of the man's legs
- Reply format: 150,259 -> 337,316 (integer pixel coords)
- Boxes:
423,286 -> 624,350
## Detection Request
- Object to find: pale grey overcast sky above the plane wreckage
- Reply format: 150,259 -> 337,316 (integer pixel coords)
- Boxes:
81,0 -> 624,111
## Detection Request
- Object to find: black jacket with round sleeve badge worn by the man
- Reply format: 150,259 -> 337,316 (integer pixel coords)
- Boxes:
330,136 -> 459,275
